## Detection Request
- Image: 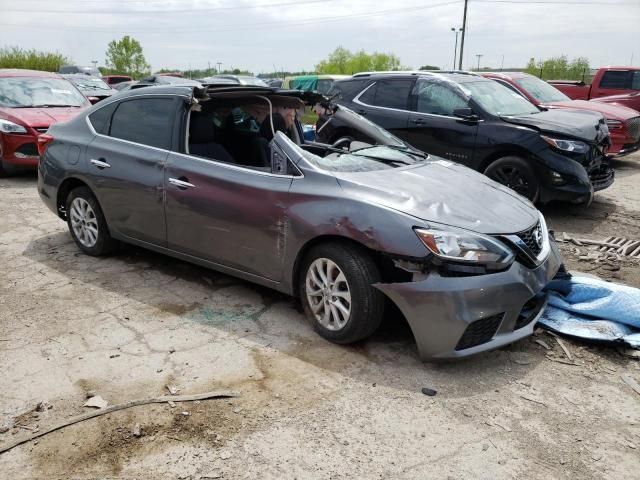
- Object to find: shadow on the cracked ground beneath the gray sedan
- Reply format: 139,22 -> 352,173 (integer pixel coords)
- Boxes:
23,230 -> 545,397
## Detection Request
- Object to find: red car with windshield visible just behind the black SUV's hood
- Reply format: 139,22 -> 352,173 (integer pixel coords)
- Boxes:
481,72 -> 640,155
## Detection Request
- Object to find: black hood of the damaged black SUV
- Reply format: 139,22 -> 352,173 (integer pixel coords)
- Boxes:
502,109 -> 609,144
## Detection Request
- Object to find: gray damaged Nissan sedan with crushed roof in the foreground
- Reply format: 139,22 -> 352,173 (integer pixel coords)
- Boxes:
38,86 -> 561,359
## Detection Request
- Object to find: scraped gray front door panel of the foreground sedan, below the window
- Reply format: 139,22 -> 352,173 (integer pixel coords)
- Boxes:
165,153 -> 292,281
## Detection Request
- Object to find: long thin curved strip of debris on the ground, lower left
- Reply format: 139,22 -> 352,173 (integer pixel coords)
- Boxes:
0,390 -> 240,454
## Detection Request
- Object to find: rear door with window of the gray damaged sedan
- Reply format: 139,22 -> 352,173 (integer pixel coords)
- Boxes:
86,96 -> 179,245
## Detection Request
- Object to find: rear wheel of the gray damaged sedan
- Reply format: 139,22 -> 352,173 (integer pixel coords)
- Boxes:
65,187 -> 118,257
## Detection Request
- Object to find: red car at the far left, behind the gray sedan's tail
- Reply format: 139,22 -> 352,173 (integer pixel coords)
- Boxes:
0,69 -> 91,177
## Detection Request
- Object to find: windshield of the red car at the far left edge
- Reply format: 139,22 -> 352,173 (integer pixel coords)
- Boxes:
0,77 -> 88,108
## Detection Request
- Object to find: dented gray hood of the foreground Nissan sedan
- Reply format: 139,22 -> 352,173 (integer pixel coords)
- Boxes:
332,156 -> 538,234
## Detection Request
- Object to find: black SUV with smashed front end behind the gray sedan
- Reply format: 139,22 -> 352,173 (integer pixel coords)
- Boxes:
316,72 -> 614,203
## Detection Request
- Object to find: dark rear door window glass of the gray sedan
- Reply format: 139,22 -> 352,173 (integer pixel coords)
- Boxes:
109,98 -> 175,150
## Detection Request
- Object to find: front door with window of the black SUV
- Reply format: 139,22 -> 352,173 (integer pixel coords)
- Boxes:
408,78 -> 478,165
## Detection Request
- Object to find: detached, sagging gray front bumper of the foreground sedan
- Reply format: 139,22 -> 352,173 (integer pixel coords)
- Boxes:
375,239 -> 562,360
